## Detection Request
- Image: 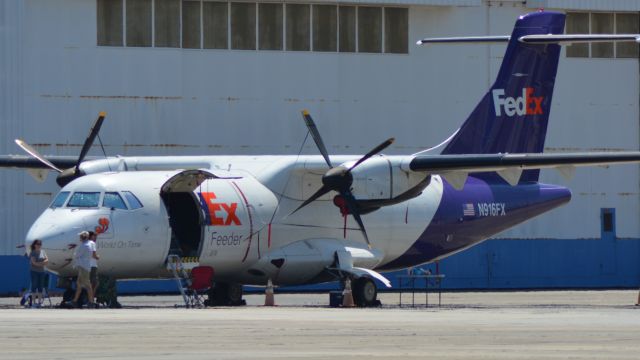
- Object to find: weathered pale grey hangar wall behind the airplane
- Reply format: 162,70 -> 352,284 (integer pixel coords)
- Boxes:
0,0 -> 640,290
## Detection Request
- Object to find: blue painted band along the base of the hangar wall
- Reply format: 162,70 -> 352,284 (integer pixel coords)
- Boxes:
0,236 -> 640,295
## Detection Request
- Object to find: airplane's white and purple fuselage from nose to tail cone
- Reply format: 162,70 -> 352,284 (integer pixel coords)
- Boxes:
27,156 -> 570,285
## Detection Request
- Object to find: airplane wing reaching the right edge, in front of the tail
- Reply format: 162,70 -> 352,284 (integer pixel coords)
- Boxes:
408,151 -> 640,189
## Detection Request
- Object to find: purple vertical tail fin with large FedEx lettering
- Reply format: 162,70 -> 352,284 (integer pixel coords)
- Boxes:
442,11 -> 565,182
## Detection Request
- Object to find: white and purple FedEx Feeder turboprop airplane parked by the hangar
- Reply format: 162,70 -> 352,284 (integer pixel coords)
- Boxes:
0,11 -> 640,306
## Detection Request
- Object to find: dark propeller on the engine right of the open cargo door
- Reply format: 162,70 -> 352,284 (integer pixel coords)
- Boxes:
292,110 -> 395,248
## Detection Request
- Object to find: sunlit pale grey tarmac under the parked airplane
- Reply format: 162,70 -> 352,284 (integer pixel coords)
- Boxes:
0,290 -> 640,359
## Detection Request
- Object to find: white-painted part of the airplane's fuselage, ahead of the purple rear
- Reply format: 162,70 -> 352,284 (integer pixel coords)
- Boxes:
26,156 -> 443,284
